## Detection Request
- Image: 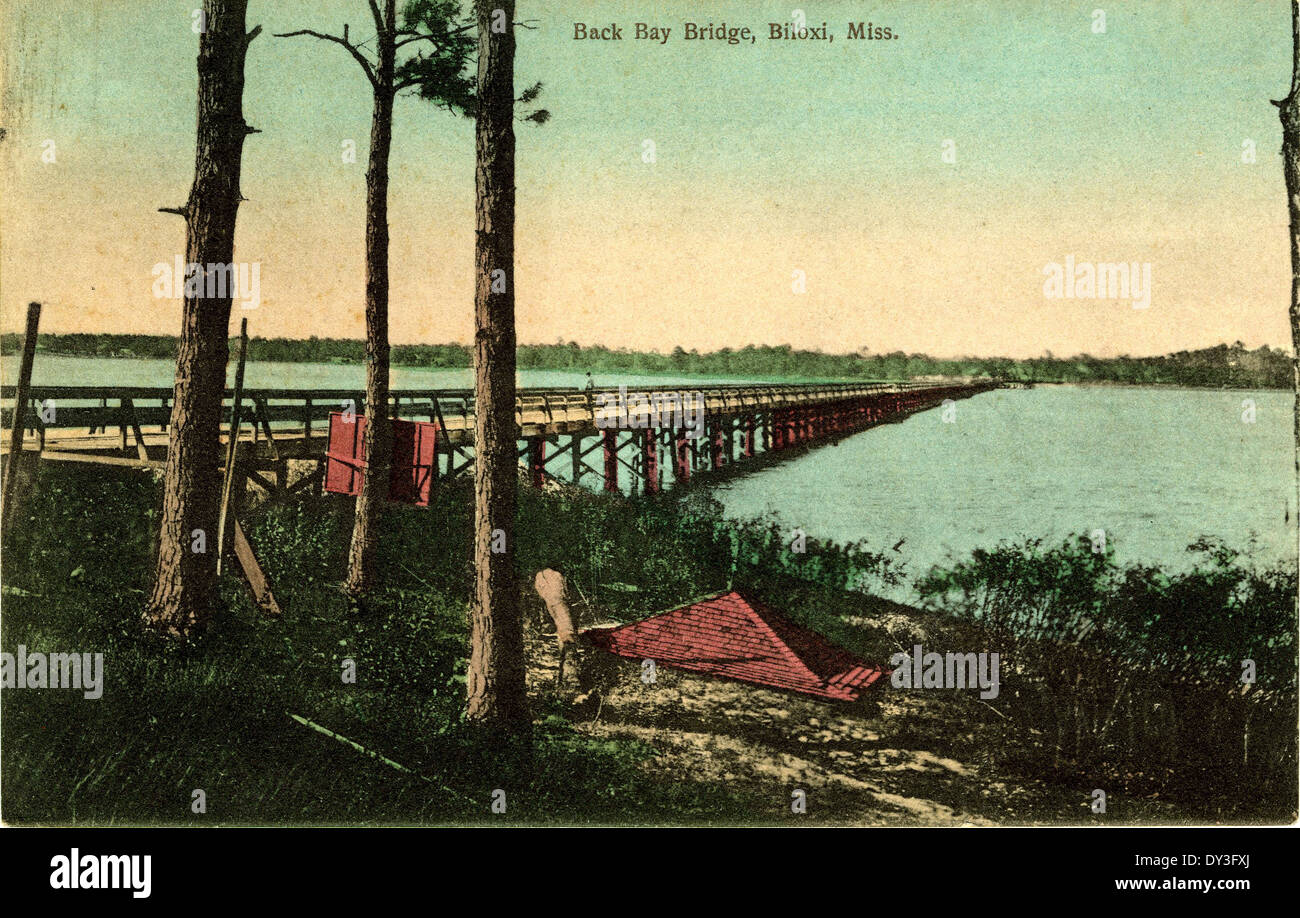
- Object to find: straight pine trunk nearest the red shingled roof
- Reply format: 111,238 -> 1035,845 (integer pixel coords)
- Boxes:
468,0 -> 529,739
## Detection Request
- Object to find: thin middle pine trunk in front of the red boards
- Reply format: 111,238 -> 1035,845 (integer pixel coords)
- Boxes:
343,0 -> 397,598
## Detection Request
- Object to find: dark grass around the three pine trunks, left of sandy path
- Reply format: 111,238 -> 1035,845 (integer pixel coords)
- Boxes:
0,468 -> 764,824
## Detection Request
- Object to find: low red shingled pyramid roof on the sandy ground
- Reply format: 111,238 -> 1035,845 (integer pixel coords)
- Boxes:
582,592 -> 883,701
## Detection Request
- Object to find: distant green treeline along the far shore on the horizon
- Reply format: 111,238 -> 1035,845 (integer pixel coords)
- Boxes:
0,334 -> 1291,389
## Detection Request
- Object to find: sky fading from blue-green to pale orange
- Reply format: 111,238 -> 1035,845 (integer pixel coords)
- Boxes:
0,0 -> 1291,356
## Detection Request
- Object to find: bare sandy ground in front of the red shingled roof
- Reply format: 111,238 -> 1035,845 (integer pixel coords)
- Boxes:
517,603 -> 1171,826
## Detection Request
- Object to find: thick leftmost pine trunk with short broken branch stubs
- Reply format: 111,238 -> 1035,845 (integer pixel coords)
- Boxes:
144,0 -> 260,640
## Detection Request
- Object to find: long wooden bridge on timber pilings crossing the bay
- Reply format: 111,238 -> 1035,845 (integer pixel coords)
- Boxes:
0,380 -> 1002,492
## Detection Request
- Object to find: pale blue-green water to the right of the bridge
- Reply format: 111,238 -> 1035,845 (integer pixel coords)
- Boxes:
716,386 -> 1296,575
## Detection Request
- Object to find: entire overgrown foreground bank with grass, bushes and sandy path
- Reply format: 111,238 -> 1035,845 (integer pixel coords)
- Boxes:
0,463 -> 1296,824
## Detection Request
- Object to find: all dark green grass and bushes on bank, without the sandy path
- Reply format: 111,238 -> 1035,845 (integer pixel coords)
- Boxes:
0,463 -> 1296,826
